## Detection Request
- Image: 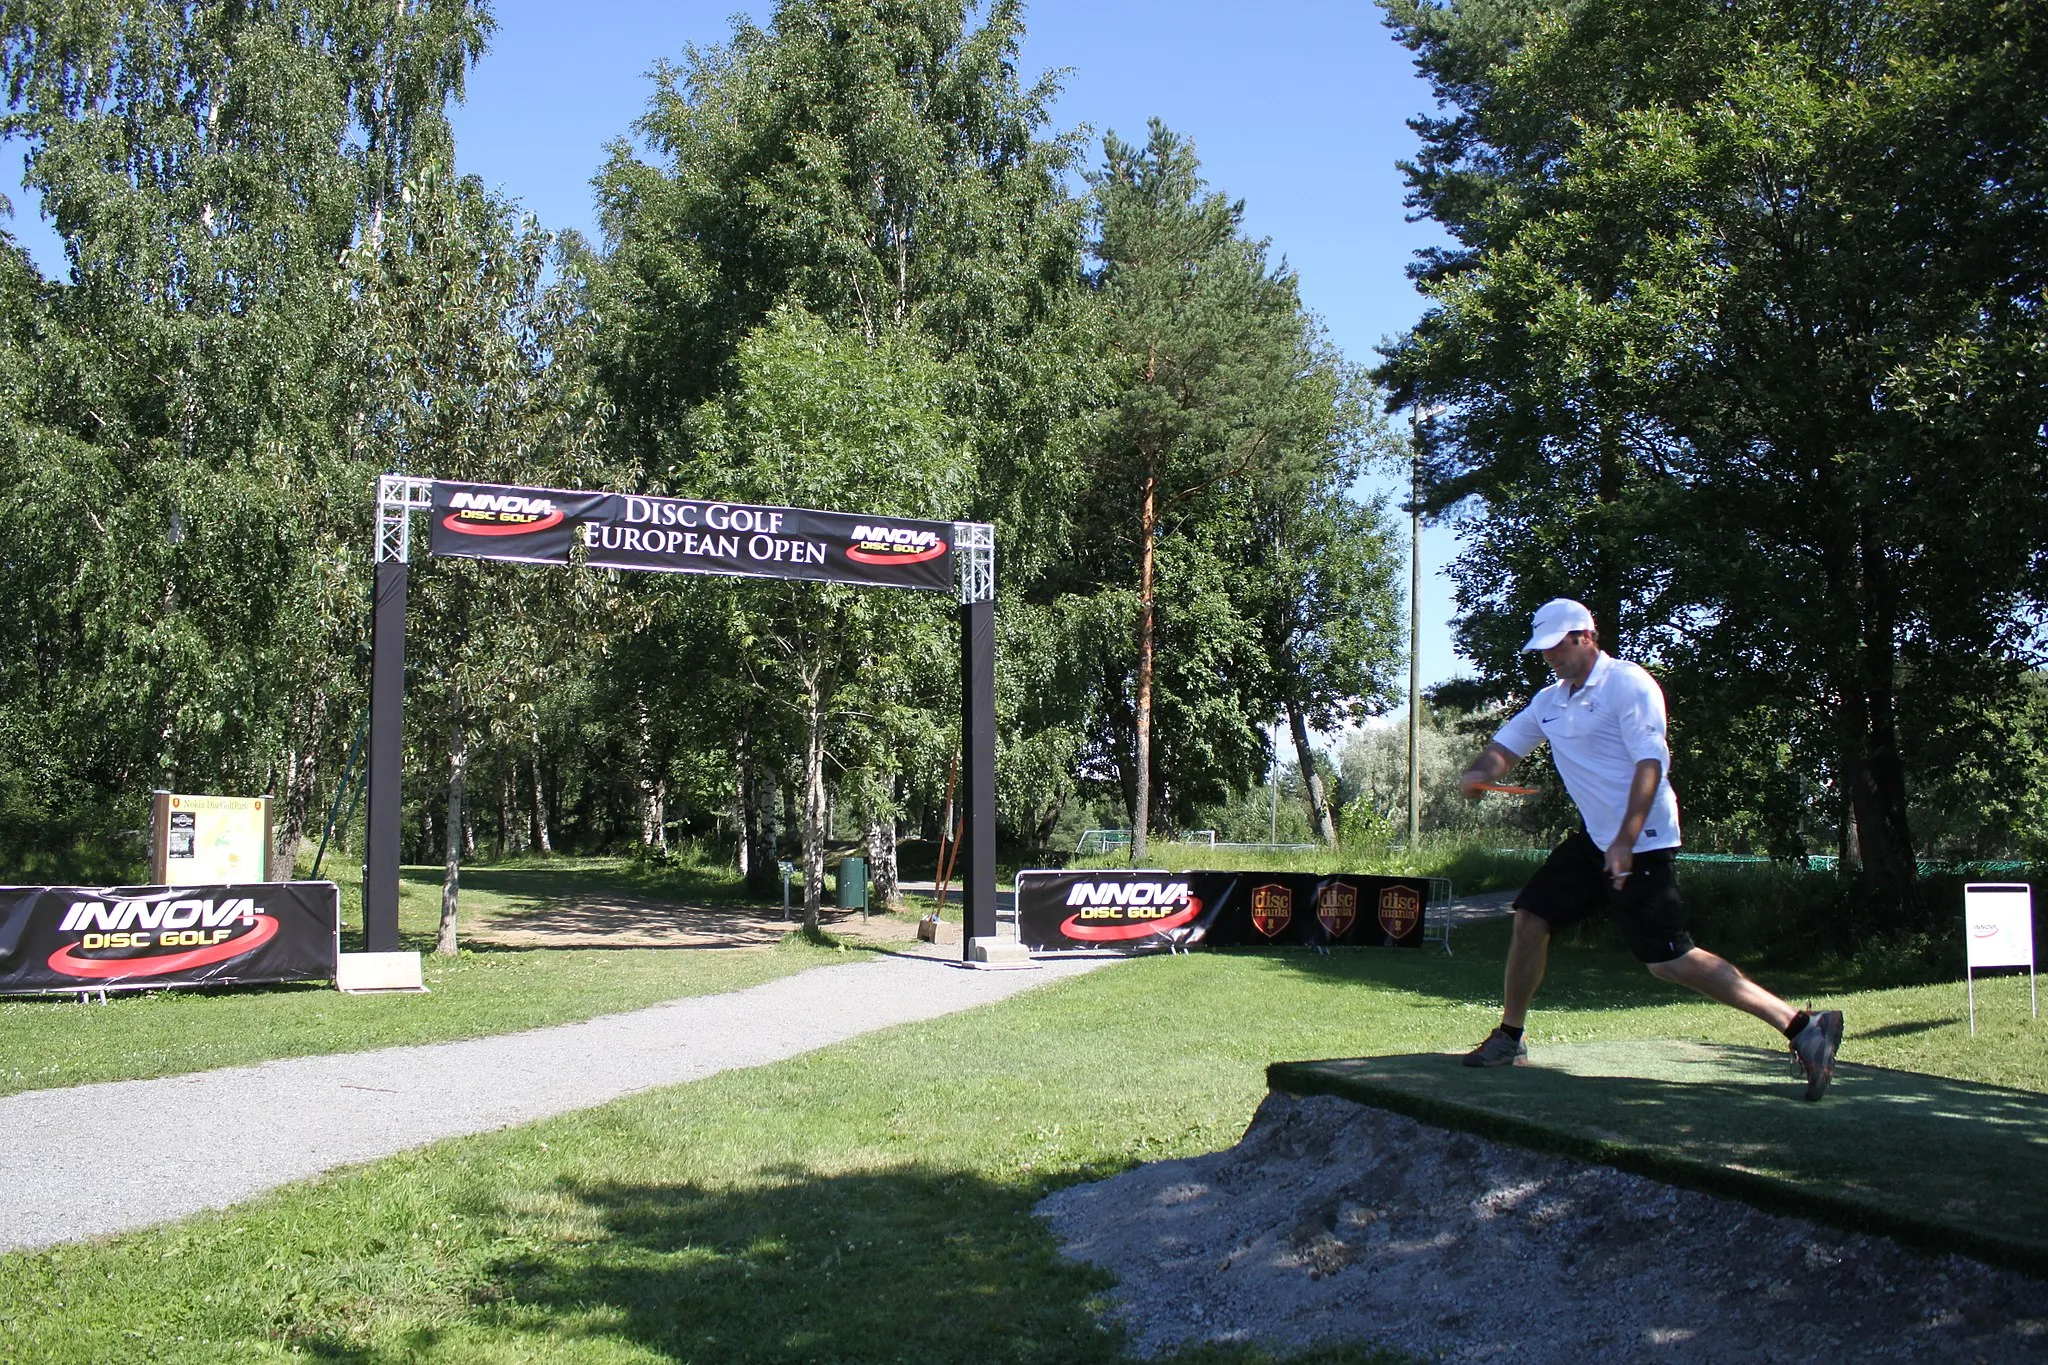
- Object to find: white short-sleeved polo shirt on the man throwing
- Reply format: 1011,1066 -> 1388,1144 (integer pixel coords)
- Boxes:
1493,651 -> 1679,853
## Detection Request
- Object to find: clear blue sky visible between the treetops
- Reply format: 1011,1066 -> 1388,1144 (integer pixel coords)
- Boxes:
14,0 -> 1458,684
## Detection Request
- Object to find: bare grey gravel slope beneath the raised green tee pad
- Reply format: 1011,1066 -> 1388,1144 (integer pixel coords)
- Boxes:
1038,1095 -> 2048,1365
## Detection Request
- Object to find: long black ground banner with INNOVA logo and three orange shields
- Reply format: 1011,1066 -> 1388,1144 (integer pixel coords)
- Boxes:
1018,870 -> 1427,952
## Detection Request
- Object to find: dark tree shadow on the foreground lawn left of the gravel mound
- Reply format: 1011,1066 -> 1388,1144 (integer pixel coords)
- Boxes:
305,1166 -> 1399,1365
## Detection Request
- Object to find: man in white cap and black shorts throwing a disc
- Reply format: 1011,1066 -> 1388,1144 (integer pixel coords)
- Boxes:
1460,598 -> 1841,1099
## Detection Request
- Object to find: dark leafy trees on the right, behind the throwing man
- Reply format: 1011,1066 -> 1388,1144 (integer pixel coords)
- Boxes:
1382,0 -> 2048,913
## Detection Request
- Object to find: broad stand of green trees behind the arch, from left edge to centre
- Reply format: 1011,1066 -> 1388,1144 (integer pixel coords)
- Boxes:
0,0 -> 1395,912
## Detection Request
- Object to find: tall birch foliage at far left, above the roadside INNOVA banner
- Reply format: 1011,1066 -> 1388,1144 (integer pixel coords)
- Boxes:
0,0 -> 487,874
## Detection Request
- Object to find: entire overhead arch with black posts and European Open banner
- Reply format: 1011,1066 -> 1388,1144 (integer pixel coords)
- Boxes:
378,475 -> 995,960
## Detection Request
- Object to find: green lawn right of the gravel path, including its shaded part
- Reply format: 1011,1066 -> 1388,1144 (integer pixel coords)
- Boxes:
0,925 -> 2048,1365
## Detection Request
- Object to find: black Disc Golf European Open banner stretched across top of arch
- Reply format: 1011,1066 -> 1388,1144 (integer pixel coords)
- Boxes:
430,479 -> 954,591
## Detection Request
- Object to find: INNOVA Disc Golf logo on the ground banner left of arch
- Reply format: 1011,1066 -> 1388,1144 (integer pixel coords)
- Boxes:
49,892 -> 279,980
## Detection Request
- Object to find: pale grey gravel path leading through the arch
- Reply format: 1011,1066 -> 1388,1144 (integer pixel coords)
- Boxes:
0,950 -> 1102,1252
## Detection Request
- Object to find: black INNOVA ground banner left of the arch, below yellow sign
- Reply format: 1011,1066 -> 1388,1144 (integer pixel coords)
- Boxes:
0,882 -> 342,995
